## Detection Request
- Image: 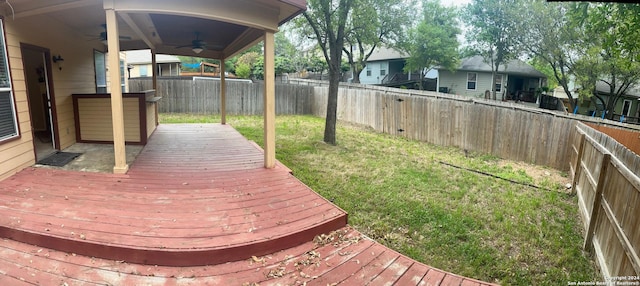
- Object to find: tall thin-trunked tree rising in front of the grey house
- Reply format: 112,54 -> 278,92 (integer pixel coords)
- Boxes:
463,0 -> 526,100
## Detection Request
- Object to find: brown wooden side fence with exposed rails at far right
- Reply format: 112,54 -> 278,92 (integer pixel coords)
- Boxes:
570,123 -> 640,282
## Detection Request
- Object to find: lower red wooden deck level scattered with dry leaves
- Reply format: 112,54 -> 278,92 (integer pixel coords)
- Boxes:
0,226 -> 493,286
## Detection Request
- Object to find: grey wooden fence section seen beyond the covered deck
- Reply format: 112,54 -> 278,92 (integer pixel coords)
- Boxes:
129,77 -> 313,115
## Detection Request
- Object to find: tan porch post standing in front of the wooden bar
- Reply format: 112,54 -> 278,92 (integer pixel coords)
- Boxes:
105,8 -> 129,174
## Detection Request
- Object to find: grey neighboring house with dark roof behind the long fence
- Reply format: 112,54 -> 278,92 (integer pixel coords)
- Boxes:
437,56 -> 547,102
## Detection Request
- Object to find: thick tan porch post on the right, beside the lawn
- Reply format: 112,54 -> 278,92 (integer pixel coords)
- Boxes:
264,31 -> 276,168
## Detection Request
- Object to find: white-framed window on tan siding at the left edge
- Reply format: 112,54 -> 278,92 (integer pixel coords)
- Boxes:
0,20 -> 18,141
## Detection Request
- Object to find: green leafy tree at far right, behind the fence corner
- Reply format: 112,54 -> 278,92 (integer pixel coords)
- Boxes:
571,3 -> 640,119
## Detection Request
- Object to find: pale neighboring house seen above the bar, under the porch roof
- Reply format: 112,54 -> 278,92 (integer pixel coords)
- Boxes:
126,50 -> 180,78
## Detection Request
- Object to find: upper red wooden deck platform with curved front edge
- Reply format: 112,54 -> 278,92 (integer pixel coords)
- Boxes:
0,124 -> 347,266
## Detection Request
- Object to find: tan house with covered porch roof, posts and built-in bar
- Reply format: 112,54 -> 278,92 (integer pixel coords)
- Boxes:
0,0 -> 306,179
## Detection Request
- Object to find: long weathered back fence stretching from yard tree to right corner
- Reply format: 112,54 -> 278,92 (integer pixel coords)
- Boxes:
311,87 -> 576,170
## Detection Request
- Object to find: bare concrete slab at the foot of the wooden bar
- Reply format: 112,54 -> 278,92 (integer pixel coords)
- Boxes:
35,143 -> 144,173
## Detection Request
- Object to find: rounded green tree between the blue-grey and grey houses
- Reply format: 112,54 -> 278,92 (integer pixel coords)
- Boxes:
403,0 -> 460,89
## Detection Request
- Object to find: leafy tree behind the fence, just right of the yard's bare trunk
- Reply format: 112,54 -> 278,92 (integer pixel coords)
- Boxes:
343,0 -> 414,83
